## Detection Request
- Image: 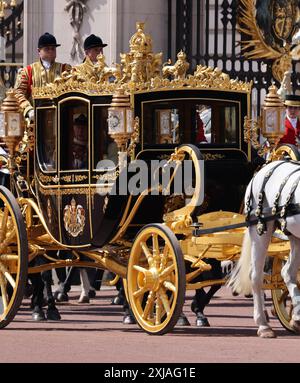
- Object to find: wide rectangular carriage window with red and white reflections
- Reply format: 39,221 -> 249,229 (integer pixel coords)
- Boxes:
143,99 -> 239,146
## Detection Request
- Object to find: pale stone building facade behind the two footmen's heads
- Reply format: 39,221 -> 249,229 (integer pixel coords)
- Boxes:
23,0 -> 168,65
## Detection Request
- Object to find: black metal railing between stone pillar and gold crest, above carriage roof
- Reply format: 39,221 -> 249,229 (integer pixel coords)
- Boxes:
168,0 -> 274,114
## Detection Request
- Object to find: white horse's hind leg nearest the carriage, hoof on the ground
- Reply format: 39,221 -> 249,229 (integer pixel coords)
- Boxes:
249,222 -> 276,338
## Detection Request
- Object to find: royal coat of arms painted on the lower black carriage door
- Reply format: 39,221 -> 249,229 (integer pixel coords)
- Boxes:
64,198 -> 85,238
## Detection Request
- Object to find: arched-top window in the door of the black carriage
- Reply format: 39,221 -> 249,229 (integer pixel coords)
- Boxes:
60,100 -> 89,170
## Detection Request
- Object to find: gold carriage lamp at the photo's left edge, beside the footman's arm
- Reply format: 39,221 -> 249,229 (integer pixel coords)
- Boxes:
0,90 -> 24,170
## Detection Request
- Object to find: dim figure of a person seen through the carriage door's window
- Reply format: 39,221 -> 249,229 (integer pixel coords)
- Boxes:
72,114 -> 88,169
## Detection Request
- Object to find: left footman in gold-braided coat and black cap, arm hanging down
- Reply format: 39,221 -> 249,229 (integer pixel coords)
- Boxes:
15,33 -> 71,121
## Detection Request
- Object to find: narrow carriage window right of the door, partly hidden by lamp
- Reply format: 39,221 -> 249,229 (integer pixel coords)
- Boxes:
94,105 -> 118,170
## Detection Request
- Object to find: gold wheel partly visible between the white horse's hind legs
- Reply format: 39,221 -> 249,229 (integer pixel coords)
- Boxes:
272,257 -> 300,332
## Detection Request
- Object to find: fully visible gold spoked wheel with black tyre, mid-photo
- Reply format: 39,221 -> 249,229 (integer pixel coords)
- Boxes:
127,224 -> 186,335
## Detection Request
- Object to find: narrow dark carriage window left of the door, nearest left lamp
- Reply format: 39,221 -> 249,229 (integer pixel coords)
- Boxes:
37,108 -> 57,172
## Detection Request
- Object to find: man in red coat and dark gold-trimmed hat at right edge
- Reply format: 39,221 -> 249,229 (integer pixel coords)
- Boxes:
279,95 -> 300,145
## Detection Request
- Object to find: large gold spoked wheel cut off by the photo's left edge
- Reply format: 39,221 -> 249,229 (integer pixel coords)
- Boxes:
0,186 -> 28,328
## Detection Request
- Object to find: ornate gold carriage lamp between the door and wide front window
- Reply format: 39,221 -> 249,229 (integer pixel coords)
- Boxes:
107,88 -> 134,168
